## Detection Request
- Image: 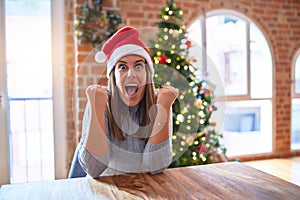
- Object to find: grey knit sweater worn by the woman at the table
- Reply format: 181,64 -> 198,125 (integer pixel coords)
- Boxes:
79,101 -> 172,177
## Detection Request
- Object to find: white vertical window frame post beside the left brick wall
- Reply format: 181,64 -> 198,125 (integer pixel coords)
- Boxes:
51,0 -> 68,179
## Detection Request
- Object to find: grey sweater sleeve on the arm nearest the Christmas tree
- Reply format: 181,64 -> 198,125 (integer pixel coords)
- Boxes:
143,113 -> 173,174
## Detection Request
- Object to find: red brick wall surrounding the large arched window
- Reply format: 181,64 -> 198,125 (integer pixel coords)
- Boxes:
65,0 -> 300,172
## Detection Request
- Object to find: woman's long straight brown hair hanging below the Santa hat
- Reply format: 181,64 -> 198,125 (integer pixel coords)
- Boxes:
108,63 -> 156,141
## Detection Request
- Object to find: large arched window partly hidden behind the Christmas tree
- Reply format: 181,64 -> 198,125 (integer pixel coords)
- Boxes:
188,10 -> 273,156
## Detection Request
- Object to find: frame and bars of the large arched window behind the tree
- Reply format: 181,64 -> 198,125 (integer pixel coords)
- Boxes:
190,9 -> 276,158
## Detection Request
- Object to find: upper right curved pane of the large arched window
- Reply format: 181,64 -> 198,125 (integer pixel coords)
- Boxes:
250,23 -> 273,98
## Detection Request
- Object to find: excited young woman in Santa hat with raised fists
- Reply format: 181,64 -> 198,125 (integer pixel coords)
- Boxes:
77,27 -> 178,177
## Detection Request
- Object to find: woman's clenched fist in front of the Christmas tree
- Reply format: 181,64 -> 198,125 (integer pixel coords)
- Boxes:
157,86 -> 179,109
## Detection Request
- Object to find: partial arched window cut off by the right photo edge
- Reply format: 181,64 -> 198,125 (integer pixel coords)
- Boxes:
291,53 -> 300,149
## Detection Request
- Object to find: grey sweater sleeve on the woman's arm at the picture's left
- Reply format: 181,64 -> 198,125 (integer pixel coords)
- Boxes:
78,105 -> 109,178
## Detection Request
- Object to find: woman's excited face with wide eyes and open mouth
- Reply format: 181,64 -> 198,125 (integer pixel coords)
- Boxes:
114,55 -> 147,106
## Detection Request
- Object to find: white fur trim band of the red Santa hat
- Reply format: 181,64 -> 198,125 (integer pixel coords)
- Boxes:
106,44 -> 154,78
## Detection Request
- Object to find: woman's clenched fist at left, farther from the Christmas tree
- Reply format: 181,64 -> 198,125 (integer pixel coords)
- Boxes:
85,85 -> 108,114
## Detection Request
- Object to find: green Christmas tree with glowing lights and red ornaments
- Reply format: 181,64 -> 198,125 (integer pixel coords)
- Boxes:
149,0 -> 226,167
